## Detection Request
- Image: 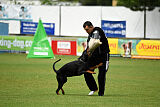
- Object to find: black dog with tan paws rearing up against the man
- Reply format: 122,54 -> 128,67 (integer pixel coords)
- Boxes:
53,59 -> 102,95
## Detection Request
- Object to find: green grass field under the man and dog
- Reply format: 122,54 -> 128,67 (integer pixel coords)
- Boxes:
0,53 -> 160,107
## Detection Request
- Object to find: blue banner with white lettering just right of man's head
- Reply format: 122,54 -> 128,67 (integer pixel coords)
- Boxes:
101,20 -> 126,38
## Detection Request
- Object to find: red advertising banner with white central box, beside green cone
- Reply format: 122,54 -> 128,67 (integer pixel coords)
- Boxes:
52,40 -> 76,55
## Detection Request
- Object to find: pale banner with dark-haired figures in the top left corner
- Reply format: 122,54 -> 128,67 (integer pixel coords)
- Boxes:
0,4 -> 32,21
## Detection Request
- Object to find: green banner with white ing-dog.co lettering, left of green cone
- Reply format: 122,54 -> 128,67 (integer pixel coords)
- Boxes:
0,36 -> 33,51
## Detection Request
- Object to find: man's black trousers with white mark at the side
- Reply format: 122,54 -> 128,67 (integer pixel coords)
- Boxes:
84,54 -> 109,95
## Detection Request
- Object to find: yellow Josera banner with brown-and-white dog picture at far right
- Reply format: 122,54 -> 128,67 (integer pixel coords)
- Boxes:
118,39 -> 160,57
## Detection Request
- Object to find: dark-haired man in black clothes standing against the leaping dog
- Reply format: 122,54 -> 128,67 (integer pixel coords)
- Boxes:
83,21 -> 110,96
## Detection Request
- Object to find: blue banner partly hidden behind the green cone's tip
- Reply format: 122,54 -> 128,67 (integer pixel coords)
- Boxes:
21,22 -> 55,35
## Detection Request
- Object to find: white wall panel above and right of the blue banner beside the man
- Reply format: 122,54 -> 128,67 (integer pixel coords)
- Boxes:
102,7 -> 144,38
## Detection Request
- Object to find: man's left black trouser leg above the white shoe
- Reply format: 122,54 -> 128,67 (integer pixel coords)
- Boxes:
84,73 -> 98,91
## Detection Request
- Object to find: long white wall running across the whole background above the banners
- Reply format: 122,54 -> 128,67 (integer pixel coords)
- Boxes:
0,6 -> 160,39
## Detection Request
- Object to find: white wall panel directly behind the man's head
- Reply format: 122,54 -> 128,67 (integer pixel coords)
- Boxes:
61,6 -> 101,36
